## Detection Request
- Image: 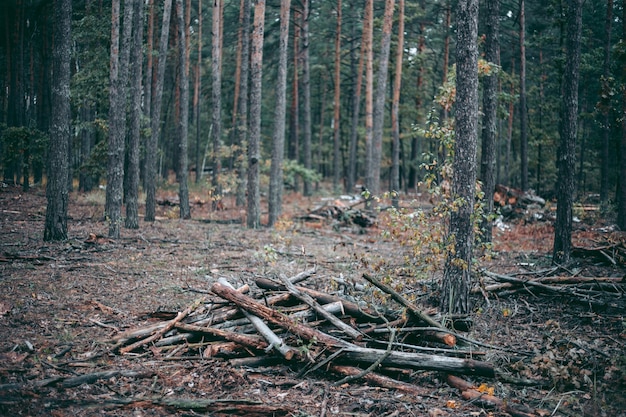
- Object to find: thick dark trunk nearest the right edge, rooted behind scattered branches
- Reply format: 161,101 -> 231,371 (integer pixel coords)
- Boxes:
552,0 -> 582,265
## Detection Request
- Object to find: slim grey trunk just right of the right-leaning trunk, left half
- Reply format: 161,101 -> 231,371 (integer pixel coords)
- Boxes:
176,0 -> 191,219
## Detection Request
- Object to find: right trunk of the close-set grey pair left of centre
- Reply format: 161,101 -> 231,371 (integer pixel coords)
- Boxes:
124,0 -> 144,229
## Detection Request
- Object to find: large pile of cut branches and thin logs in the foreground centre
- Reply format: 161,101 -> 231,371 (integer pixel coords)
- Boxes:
110,270 -> 538,416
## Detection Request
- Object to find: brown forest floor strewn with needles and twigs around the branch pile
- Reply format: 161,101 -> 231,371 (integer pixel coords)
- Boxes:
0,186 -> 626,417
